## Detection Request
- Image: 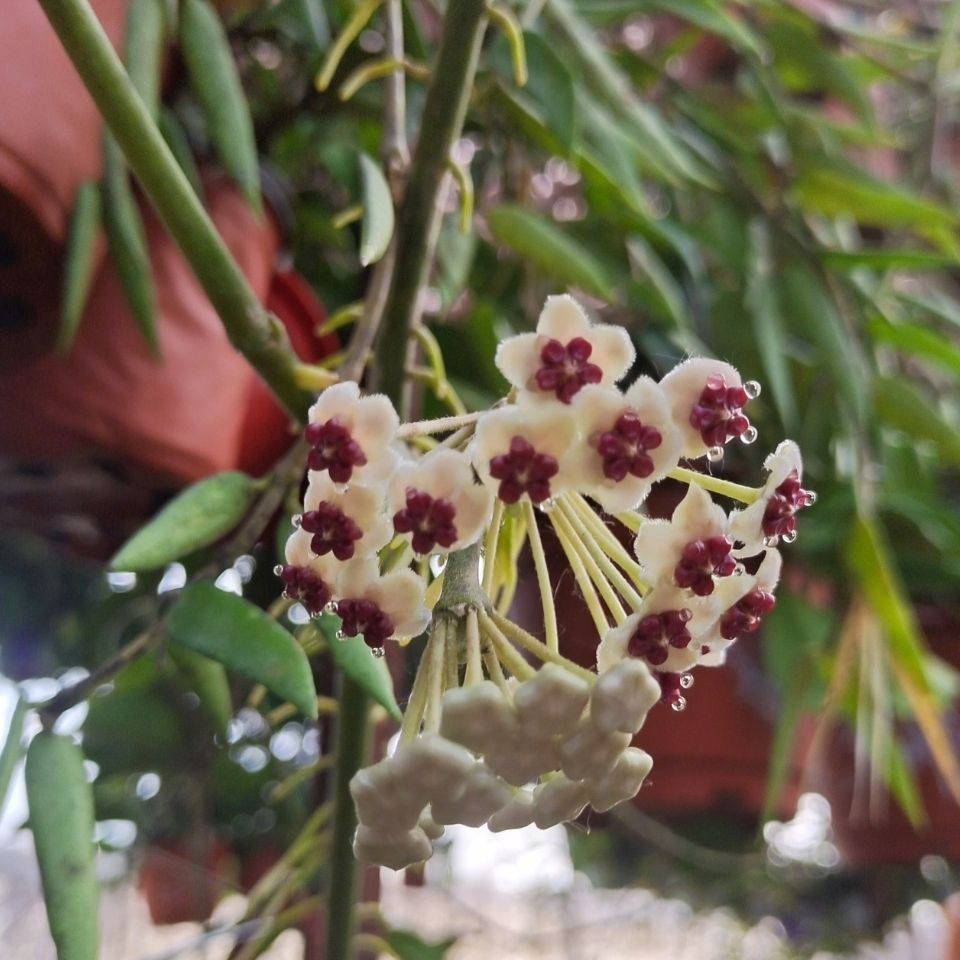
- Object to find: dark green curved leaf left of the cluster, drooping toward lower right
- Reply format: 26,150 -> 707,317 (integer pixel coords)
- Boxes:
166,583 -> 317,718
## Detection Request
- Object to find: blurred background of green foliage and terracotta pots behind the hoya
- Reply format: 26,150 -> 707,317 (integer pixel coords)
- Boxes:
0,0 -> 960,960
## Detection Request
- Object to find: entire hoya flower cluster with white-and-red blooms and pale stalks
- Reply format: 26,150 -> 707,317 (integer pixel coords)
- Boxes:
278,297 -> 814,869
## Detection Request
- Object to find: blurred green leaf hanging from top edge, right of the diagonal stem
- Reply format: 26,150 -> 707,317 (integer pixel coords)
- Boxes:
180,0 -> 261,213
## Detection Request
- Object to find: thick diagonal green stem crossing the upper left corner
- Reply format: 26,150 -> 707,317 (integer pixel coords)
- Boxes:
39,0 -> 312,418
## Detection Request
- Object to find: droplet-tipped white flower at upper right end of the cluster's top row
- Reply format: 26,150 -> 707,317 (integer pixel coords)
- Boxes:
660,357 -> 760,459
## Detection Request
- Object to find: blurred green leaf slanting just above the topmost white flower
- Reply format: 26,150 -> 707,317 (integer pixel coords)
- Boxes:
487,206 -> 613,300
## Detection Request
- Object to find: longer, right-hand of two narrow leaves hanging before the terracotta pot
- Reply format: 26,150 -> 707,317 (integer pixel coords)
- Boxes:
103,134 -> 160,356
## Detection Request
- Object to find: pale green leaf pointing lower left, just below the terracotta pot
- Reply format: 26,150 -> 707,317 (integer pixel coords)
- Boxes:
110,471 -> 256,573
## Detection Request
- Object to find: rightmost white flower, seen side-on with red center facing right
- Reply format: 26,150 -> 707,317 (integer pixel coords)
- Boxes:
730,440 -> 817,556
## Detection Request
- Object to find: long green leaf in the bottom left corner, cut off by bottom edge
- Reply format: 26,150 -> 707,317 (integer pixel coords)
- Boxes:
26,732 -> 99,960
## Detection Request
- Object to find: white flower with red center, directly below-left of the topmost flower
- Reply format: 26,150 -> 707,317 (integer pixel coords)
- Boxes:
469,406 -> 577,504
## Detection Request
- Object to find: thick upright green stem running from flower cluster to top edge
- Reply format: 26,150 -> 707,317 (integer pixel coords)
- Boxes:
377,0 -> 487,397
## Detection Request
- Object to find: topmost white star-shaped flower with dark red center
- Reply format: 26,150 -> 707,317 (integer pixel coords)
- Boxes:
496,296 -> 636,403
